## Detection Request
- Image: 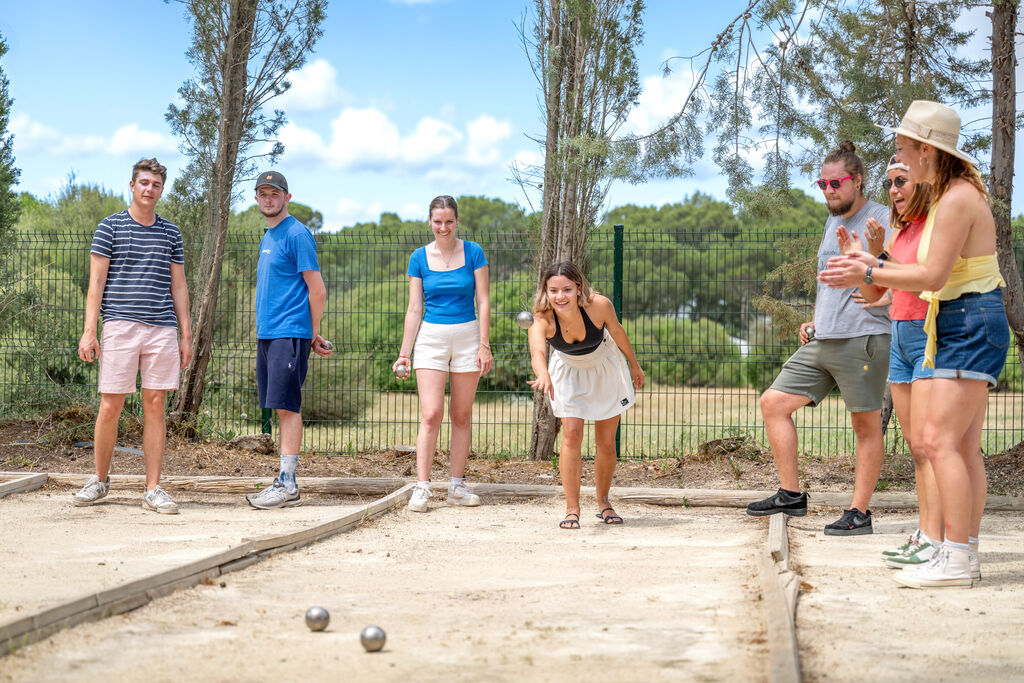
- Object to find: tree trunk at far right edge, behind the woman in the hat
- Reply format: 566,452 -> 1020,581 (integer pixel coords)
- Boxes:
989,0 -> 1024,376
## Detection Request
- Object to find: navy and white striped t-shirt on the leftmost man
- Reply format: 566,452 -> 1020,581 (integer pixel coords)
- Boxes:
91,209 -> 185,328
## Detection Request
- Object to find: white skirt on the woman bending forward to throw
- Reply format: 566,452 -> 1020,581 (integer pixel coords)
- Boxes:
548,330 -> 636,420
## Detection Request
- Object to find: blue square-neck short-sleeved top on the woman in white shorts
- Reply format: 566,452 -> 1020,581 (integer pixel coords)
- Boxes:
409,240 -> 487,325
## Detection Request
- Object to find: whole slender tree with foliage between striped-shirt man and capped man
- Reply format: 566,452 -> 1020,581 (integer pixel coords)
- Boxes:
166,0 -> 327,423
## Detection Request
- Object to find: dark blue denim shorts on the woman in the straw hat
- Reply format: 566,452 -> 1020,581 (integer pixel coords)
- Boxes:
934,289 -> 1010,387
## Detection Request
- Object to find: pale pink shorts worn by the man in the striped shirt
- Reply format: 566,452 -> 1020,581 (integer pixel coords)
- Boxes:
99,321 -> 181,393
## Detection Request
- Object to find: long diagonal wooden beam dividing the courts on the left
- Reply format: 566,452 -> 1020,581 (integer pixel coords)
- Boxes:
0,484 -> 413,656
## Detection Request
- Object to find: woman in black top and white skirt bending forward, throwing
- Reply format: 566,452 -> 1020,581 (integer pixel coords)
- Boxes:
527,262 -> 643,529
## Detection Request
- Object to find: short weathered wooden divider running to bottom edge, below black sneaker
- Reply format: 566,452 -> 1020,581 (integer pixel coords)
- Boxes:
758,514 -> 801,683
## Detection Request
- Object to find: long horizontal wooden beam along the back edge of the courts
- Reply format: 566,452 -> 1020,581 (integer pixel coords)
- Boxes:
25,472 -> 1024,512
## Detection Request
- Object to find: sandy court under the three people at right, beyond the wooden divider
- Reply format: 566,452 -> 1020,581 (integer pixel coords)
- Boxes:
790,513 -> 1024,681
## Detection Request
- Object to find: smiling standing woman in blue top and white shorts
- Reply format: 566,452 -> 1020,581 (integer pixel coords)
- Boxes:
391,196 -> 494,512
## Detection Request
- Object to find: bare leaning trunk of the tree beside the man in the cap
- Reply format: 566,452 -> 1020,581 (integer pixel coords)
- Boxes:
172,0 -> 258,429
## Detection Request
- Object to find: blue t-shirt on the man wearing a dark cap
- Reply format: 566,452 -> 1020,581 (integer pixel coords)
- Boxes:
256,216 -> 319,339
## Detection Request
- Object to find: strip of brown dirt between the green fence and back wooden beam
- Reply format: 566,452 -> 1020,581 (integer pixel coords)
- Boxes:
0,415 -> 1024,496
